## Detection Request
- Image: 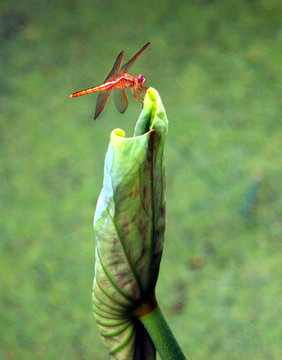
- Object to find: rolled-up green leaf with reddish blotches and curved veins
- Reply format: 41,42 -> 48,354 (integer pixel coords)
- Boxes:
93,88 -> 168,360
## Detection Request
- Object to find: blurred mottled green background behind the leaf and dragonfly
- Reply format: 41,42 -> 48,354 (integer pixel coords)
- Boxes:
0,0 -> 282,360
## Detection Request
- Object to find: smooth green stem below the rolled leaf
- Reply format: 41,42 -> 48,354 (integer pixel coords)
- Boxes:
139,306 -> 186,360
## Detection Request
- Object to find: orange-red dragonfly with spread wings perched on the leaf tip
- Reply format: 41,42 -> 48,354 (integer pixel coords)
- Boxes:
70,42 -> 150,120
